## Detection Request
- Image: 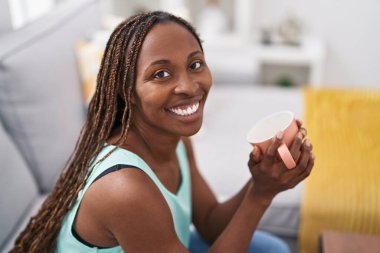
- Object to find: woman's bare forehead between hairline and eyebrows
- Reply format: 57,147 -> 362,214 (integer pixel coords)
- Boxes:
139,22 -> 201,62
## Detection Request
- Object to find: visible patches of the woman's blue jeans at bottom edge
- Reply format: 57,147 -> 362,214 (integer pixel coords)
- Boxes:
189,230 -> 290,253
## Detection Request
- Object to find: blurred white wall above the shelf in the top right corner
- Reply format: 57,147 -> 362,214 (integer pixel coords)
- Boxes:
252,0 -> 380,88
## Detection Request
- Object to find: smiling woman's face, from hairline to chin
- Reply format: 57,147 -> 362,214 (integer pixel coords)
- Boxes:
132,22 -> 212,136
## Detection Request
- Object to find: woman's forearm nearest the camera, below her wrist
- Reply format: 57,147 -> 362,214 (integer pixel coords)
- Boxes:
209,185 -> 271,253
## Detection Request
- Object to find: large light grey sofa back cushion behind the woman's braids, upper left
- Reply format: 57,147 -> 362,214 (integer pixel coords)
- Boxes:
0,0 -> 99,192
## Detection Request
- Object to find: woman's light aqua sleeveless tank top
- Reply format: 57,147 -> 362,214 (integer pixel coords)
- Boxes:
55,141 -> 191,253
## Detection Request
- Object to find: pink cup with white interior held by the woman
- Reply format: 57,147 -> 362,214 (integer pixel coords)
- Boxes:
247,111 -> 299,169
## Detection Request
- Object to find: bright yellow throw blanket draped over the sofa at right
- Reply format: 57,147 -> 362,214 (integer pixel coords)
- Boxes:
299,88 -> 380,253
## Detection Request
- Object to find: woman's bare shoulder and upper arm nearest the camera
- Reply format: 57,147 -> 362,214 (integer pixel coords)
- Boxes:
98,168 -> 187,253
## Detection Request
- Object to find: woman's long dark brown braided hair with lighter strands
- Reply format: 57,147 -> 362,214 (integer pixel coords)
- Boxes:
11,11 -> 203,253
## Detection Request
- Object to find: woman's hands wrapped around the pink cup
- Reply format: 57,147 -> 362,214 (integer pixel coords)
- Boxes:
248,120 -> 315,200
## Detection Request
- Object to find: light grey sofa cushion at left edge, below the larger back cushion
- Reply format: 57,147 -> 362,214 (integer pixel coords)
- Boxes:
0,122 -> 38,249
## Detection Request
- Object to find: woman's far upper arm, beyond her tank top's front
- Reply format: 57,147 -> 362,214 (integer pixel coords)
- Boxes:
182,138 -> 218,239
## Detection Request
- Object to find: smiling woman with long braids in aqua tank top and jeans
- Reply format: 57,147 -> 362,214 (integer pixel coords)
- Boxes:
12,12 -> 314,253
